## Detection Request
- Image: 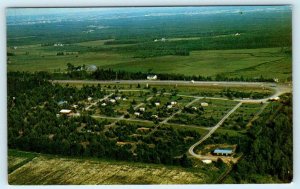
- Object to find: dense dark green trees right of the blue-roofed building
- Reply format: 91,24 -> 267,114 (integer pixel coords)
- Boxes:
231,95 -> 293,183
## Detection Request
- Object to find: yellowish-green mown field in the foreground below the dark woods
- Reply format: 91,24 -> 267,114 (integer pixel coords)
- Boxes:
8,152 -> 216,185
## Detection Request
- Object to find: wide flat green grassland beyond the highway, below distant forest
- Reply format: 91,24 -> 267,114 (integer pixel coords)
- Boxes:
8,43 -> 292,80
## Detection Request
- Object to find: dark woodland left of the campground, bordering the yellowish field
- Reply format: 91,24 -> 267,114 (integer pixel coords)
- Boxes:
8,73 -> 200,167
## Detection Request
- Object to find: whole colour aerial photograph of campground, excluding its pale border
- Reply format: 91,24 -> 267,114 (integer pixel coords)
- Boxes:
5,5 -> 293,185
